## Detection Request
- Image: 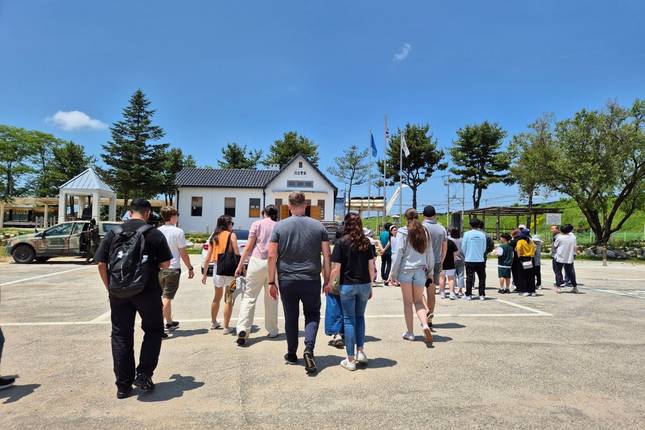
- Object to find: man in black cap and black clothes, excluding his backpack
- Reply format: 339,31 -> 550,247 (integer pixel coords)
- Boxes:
94,199 -> 172,399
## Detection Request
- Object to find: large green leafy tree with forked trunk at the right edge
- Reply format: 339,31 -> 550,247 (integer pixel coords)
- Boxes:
542,99 -> 645,245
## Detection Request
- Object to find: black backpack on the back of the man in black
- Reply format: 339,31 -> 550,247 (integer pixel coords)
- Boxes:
108,224 -> 153,299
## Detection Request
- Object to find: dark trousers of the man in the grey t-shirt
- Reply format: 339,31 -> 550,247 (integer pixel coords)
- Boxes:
278,280 -> 322,354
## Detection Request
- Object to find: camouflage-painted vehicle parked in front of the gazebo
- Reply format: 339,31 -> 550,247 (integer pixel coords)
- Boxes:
6,220 -> 121,264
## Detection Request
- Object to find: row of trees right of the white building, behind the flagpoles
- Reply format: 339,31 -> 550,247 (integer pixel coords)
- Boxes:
328,99 -> 645,244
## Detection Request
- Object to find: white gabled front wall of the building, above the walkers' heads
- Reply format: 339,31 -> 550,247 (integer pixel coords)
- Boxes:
267,157 -> 335,221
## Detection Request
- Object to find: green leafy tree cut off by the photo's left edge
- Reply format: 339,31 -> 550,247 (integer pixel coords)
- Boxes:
0,125 -> 34,201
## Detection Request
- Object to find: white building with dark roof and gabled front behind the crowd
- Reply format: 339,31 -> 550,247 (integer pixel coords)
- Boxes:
176,154 -> 338,232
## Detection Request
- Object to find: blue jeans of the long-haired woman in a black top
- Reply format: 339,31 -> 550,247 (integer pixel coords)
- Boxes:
340,284 -> 372,356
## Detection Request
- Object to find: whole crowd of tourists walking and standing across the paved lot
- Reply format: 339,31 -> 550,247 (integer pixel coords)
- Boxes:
0,192 -> 578,398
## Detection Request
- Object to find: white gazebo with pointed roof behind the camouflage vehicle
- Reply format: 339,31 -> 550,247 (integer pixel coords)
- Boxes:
58,169 -> 116,223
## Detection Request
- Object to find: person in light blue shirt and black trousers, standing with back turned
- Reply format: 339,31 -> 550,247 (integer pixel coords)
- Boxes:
461,218 -> 486,300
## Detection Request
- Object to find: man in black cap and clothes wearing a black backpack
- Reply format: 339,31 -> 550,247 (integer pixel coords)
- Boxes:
94,199 -> 172,399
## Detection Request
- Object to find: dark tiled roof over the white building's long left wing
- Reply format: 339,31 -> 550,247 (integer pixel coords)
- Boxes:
175,169 -> 280,188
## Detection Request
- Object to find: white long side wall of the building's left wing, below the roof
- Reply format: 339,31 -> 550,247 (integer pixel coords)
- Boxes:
177,187 -> 264,233
